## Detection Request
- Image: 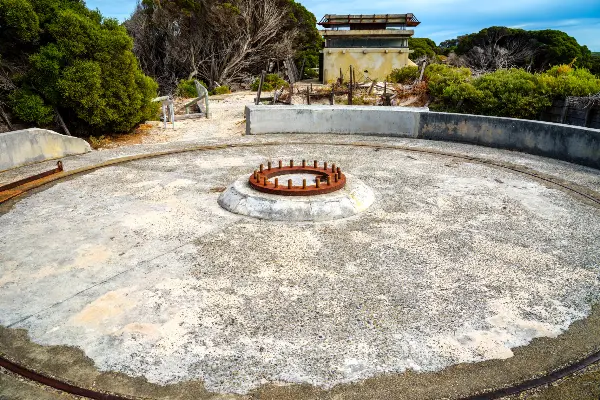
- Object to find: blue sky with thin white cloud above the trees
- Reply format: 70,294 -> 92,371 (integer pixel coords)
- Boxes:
86,0 -> 600,52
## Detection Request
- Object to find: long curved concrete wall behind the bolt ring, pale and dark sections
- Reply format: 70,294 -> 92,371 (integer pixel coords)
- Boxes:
246,106 -> 600,169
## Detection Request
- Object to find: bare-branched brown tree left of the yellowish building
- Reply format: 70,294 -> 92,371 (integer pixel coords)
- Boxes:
126,0 -> 321,92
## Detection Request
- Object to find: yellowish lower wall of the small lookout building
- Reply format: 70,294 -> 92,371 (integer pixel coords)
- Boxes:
323,48 -> 416,83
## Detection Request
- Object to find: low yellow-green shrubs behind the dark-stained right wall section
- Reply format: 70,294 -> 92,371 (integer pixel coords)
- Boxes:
425,65 -> 600,119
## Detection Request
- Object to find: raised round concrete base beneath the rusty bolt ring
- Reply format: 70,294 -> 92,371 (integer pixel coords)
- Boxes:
219,175 -> 375,222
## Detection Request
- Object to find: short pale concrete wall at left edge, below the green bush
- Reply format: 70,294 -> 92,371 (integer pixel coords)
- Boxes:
0,128 -> 92,171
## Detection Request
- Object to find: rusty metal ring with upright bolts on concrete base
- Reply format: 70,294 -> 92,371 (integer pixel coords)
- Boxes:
249,160 -> 346,196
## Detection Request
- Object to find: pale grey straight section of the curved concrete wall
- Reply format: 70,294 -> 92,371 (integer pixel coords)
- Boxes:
246,105 -> 423,137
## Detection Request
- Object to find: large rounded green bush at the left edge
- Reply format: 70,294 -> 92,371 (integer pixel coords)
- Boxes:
0,0 -> 158,135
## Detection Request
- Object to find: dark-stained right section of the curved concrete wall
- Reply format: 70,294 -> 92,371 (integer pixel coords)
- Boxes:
418,112 -> 600,169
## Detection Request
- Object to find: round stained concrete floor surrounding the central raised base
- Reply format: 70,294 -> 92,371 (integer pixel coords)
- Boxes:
0,136 -> 600,398
